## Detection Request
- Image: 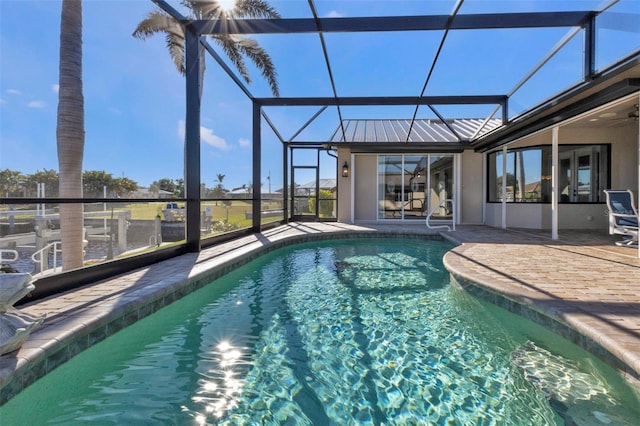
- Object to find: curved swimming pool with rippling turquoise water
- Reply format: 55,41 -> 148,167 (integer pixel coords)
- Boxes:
0,239 -> 639,425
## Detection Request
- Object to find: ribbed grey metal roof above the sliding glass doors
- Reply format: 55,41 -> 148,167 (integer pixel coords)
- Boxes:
330,118 -> 502,143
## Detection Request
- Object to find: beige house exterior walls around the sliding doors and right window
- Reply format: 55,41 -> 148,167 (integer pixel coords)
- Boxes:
337,116 -> 638,229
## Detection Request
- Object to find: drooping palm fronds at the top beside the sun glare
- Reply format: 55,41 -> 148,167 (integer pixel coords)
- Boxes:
133,0 -> 280,96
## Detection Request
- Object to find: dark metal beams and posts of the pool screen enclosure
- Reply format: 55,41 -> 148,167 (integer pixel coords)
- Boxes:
152,0 -> 604,252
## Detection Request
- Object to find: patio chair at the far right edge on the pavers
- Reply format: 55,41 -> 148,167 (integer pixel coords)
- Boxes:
604,189 -> 638,246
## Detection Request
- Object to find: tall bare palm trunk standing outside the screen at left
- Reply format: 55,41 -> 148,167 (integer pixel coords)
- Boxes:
56,0 -> 84,270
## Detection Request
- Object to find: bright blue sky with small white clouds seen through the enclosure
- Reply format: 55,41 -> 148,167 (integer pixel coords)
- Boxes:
0,0 -> 640,190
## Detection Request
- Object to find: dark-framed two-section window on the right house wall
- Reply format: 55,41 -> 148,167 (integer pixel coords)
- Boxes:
488,145 -> 610,203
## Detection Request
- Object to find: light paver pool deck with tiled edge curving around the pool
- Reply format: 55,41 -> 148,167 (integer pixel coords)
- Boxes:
0,222 -> 640,403
